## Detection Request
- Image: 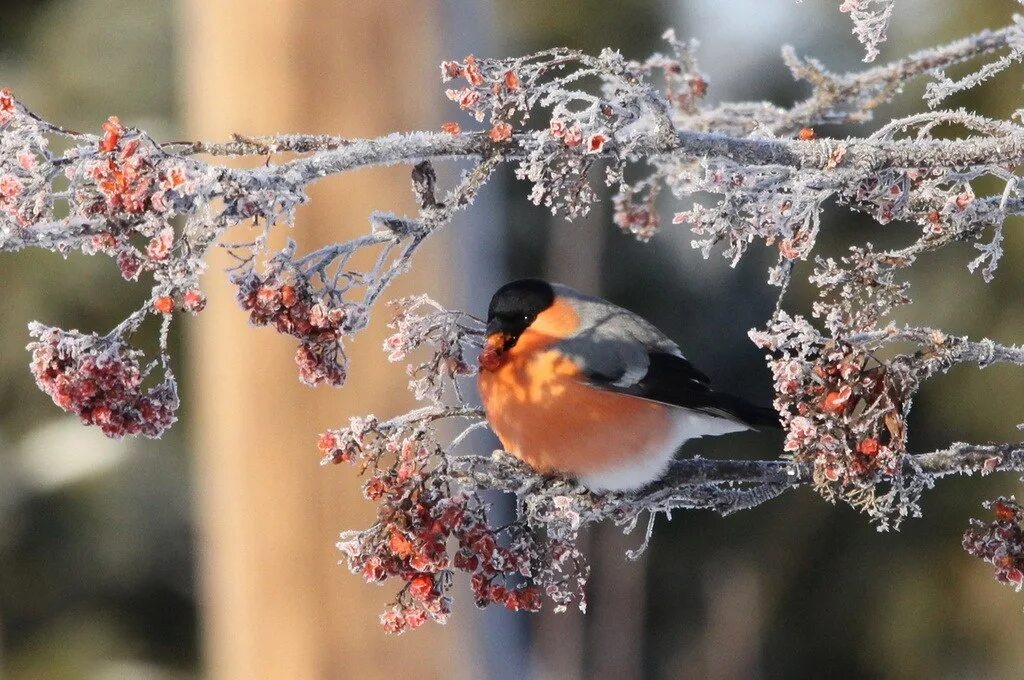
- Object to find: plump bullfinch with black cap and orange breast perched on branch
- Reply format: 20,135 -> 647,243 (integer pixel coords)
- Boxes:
477,279 -> 780,493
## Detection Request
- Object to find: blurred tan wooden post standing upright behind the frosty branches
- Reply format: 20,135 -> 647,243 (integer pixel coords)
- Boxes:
180,0 -> 468,680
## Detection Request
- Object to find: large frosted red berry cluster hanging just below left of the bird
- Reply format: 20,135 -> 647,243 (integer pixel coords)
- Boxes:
318,416 -> 544,633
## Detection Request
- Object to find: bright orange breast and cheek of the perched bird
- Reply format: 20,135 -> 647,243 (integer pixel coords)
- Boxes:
478,301 -> 672,475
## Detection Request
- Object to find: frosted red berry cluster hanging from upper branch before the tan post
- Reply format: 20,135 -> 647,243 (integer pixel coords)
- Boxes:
233,266 -> 348,386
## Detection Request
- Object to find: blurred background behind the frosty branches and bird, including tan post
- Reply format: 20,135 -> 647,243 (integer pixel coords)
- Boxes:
0,0 -> 1024,680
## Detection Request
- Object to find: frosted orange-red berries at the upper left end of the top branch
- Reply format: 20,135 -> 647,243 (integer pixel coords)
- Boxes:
0,104 -> 202,290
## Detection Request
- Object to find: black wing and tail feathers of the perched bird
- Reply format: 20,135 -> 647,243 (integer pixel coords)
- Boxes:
590,352 -> 779,427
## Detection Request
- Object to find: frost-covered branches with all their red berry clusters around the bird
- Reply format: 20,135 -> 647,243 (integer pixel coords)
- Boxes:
6,15 -> 1024,633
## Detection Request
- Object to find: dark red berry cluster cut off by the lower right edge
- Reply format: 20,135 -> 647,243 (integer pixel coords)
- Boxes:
964,497 -> 1024,591
